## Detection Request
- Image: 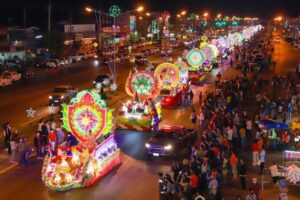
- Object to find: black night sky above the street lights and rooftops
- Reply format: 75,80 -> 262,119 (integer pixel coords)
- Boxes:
0,0 -> 300,29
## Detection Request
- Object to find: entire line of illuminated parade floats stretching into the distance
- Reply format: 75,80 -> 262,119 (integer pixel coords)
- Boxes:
42,26 -> 261,191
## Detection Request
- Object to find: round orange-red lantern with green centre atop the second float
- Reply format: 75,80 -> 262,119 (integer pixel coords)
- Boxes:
125,71 -> 160,97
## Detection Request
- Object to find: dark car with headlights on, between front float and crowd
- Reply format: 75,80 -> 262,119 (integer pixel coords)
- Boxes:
145,125 -> 196,156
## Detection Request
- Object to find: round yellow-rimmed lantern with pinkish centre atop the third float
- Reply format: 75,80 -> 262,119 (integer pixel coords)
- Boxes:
154,63 -> 180,88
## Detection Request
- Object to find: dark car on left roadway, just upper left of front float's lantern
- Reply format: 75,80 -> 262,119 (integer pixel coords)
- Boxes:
49,85 -> 78,105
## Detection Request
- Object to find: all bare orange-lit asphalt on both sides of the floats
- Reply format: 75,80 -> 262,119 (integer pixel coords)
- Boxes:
0,33 -> 300,200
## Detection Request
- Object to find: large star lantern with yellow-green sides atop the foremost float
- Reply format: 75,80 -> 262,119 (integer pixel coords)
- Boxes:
62,90 -> 112,142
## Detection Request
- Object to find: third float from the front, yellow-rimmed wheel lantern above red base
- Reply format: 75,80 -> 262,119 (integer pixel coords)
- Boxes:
154,63 -> 188,108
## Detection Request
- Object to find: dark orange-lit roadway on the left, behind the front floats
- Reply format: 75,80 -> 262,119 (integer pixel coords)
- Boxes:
0,49 -> 181,126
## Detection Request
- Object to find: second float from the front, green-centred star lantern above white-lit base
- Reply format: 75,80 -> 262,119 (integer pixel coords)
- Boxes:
117,71 -> 161,131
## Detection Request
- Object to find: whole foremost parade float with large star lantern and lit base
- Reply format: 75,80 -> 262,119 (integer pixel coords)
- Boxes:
42,91 -> 121,191
